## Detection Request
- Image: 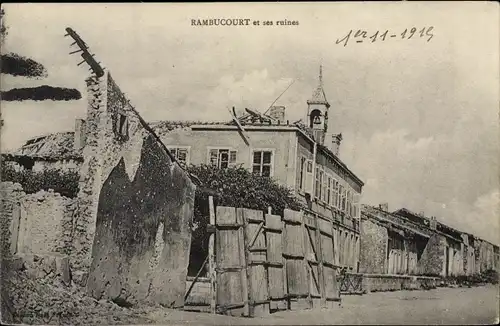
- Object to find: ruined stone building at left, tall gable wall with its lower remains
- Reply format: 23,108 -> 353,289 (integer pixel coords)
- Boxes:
1,71 -> 195,307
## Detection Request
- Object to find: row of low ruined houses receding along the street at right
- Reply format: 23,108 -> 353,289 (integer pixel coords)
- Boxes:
360,205 -> 500,277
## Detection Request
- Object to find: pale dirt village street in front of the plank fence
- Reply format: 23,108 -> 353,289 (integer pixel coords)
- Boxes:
143,285 -> 498,325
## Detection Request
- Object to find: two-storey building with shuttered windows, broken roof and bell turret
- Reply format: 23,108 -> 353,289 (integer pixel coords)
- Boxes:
152,65 -> 364,270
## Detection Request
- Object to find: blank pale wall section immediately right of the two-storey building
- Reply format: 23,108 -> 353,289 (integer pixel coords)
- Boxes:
359,219 -> 388,274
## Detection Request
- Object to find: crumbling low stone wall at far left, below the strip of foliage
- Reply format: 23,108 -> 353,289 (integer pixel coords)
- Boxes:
0,182 -> 75,322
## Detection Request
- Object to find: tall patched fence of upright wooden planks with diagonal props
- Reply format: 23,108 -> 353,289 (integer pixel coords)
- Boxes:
186,206 -> 340,317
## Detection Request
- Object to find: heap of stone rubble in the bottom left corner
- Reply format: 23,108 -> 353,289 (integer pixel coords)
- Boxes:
4,256 -> 152,325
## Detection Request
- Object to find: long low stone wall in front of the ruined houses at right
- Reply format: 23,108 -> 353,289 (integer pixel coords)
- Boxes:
363,274 -> 440,293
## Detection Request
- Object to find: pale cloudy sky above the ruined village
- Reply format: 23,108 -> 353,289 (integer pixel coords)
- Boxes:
1,2 -> 500,244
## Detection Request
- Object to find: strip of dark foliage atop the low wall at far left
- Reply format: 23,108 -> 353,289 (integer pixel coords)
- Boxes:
1,162 -> 79,198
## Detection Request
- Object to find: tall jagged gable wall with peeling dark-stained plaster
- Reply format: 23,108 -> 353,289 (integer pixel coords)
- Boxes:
77,72 -> 195,307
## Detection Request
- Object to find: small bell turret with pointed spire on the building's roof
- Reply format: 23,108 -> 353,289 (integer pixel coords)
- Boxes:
307,65 -> 330,144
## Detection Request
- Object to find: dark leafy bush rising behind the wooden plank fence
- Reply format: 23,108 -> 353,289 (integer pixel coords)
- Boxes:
184,165 -> 301,275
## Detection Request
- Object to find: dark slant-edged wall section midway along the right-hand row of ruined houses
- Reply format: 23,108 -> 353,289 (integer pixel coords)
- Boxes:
417,233 -> 446,276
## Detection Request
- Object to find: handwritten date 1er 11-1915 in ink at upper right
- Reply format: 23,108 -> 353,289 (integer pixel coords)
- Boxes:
335,26 -> 434,46
